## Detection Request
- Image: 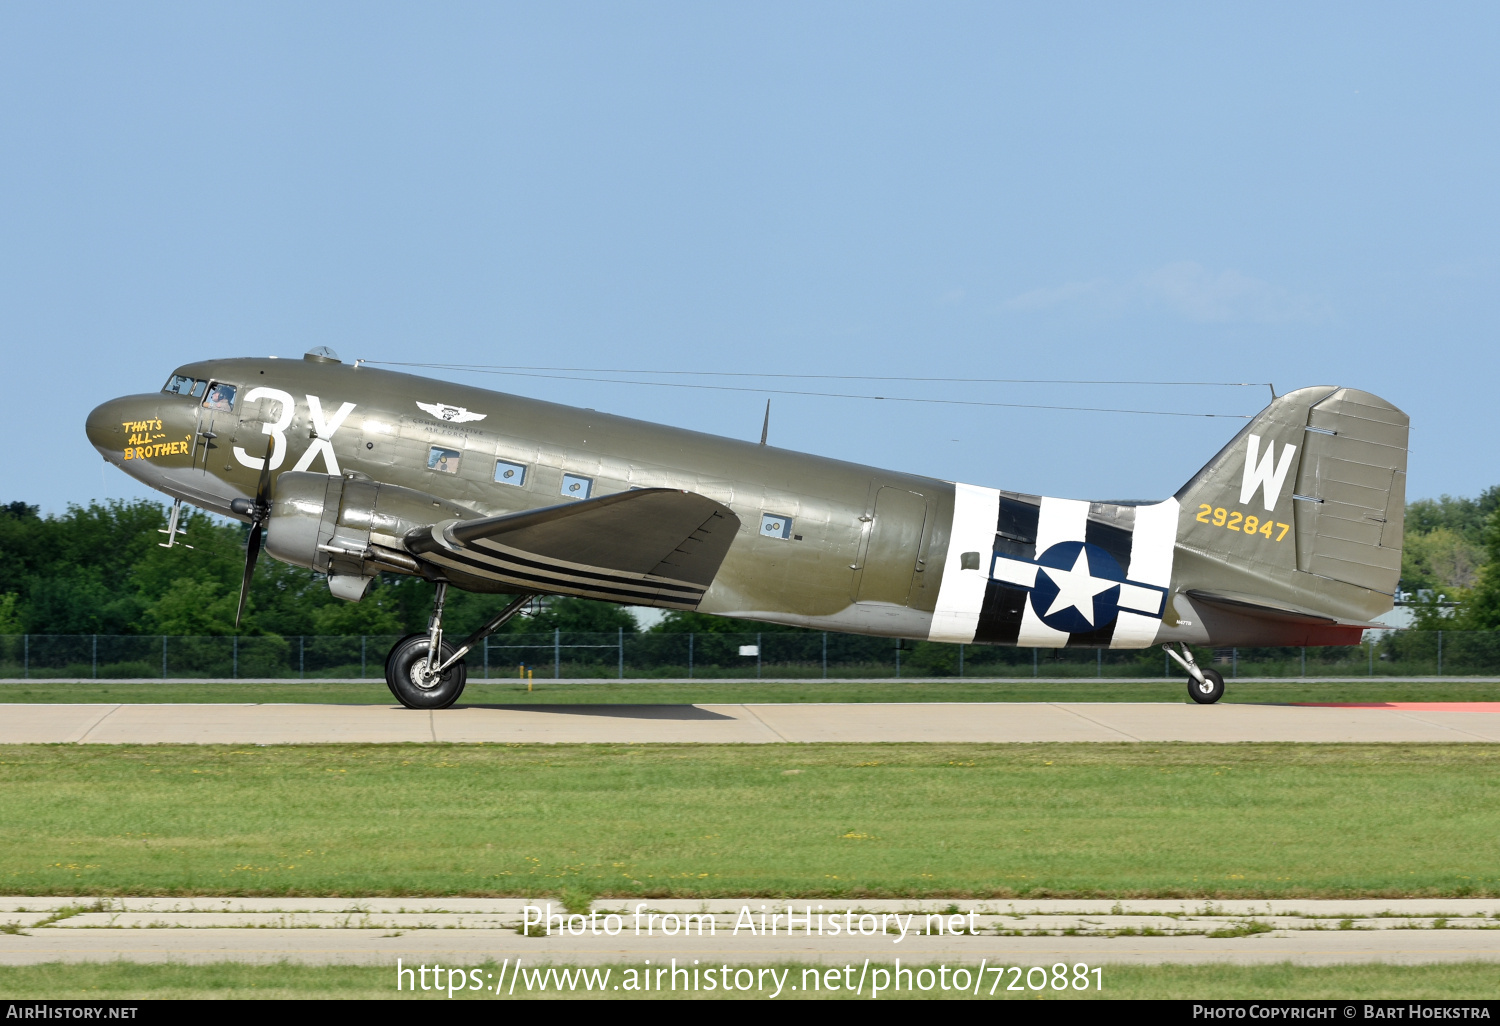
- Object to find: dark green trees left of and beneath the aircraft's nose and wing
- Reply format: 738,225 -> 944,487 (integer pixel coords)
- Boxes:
0,500 -> 792,636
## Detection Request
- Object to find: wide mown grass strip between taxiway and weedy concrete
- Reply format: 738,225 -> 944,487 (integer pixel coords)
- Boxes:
0,744 -> 1500,894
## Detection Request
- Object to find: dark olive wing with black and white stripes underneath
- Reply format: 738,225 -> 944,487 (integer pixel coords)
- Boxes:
405,488 -> 740,609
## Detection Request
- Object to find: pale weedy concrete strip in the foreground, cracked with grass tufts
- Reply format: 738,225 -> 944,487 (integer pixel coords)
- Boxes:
0,897 -> 1500,972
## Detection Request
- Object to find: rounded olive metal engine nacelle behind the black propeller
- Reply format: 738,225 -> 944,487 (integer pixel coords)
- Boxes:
266,471 -> 477,602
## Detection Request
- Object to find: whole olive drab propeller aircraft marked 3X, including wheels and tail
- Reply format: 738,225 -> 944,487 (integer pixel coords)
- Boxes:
87,350 -> 1409,708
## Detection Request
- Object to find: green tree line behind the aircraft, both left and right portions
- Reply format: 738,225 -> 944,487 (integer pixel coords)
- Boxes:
0,486 -> 1500,636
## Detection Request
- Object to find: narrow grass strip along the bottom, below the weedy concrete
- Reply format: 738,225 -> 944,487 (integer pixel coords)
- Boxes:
0,962 -> 1497,1002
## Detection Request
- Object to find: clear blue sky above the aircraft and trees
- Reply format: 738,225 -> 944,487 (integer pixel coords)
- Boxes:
0,3 -> 1500,510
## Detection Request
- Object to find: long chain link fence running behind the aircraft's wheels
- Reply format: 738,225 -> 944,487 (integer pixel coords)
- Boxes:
0,632 -> 1500,681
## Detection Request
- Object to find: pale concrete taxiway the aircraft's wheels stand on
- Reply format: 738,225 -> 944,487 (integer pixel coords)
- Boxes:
0,702 -> 1500,744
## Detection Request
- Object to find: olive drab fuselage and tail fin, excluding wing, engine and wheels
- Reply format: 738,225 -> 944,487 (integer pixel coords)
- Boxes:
87,357 -> 1406,648
